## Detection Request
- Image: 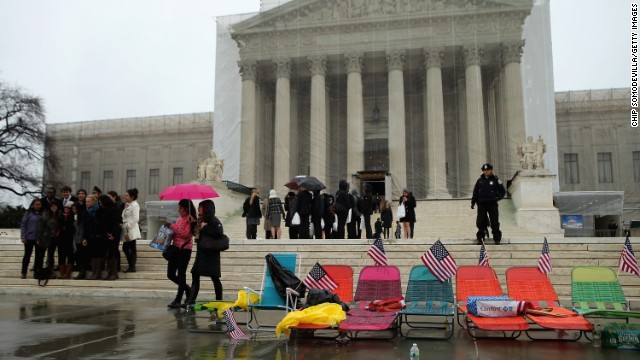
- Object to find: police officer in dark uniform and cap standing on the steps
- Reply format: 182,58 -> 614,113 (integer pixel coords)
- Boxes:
471,164 -> 506,245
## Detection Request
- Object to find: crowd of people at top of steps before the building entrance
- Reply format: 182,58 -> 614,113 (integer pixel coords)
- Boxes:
242,180 -> 416,239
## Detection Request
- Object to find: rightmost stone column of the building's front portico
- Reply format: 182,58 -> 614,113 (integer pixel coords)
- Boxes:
500,40 -> 526,179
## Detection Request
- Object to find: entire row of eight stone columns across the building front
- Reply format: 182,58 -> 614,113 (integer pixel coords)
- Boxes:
239,42 -> 524,198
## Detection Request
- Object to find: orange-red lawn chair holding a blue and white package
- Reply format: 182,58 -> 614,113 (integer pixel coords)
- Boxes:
456,266 -> 529,339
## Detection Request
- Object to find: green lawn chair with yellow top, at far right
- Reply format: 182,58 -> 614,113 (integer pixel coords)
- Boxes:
571,266 -> 640,322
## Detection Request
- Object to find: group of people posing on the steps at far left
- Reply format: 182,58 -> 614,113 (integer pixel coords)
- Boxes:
20,186 -> 140,280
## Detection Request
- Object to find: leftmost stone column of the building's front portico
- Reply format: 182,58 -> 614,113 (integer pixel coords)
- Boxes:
238,60 -> 258,187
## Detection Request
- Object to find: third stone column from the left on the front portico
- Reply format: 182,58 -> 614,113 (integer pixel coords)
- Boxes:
307,55 -> 328,184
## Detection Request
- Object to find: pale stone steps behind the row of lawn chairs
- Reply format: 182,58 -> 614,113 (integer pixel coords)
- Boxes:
0,234 -> 640,308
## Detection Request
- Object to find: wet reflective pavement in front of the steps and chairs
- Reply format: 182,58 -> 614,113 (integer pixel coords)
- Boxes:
0,295 -> 640,360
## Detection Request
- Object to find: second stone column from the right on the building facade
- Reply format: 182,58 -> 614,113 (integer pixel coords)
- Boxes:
462,45 -> 489,195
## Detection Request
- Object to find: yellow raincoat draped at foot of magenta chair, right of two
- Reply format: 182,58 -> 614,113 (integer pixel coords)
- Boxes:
276,303 -> 347,338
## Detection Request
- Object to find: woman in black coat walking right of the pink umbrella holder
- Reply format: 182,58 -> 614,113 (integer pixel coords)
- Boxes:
185,200 -> 224,306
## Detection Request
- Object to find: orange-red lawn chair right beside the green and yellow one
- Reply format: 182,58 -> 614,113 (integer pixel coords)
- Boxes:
506,267 -> 593,341
